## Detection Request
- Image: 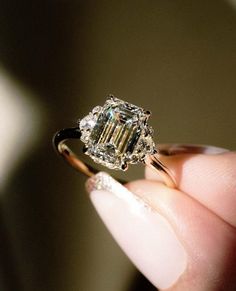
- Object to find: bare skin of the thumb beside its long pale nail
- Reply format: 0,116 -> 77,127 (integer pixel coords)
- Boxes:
127,180 -> 236,291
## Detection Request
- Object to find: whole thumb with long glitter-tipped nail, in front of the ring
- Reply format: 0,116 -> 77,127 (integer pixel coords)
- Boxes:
87,173 -> 236,291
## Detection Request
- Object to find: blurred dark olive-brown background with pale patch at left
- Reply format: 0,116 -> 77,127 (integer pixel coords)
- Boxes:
0,0 -> 236,291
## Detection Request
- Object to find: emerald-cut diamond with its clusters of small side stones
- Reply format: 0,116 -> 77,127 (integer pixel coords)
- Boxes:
79,96 -> 156,170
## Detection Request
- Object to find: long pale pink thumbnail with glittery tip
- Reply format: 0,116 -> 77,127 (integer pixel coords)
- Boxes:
87,172 -> 187,289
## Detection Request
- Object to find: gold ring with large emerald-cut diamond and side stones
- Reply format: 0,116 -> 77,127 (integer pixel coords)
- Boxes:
53,95 -> 176,188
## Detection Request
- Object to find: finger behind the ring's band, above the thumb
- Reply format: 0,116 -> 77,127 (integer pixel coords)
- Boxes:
145,152 -> 236,226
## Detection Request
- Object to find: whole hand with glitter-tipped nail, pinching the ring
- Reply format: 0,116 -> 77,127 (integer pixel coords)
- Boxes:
87,152 -> 236,291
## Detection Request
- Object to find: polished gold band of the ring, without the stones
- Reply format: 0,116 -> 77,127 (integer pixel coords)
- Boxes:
53,127 -> 176,188
